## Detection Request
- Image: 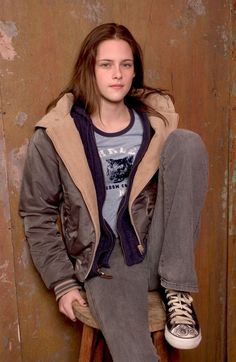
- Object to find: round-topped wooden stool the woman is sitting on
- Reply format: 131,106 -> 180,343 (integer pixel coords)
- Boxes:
73,291 -> 179,362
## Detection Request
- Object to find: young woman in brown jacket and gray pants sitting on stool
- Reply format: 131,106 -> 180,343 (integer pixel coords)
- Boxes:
20,23 -> 207,362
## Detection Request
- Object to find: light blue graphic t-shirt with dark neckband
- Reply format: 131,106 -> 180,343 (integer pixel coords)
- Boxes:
95,111 -> 143,234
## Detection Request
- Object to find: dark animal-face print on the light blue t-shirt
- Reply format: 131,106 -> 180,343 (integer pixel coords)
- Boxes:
106,156 -> 134,183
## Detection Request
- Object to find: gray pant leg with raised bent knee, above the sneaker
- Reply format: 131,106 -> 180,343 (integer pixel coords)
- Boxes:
147,129 -> 208,292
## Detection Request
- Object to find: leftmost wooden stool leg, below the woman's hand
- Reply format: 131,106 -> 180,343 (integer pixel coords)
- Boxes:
79,324 -> 95,362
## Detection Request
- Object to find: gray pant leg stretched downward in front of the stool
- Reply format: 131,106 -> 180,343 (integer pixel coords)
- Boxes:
85,242 -> 158,362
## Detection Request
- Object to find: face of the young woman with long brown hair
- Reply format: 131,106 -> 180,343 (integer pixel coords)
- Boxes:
95,39 -> 135,107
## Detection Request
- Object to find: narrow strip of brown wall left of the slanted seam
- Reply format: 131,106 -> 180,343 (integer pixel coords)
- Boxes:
0,105 -> 21,362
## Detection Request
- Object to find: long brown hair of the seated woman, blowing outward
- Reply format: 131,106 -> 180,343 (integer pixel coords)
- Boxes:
46,23 -> 169,123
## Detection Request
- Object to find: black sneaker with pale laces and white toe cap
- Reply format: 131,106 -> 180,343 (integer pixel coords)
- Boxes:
162,289 -> 202,349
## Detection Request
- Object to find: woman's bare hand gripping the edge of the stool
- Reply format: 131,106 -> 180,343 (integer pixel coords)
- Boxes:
58,289 -> 87,322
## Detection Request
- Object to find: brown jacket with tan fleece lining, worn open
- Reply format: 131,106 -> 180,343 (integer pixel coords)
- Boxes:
20,94 -> 178,299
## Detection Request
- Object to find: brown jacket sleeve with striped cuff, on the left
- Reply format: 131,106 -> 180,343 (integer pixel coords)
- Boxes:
20,129 -> 79,299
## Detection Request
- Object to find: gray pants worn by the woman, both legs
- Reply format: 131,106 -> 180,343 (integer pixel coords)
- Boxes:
85,129 -> 208,362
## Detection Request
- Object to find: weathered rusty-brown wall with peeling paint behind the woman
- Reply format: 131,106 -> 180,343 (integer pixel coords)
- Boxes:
0,0 -> 233,362
